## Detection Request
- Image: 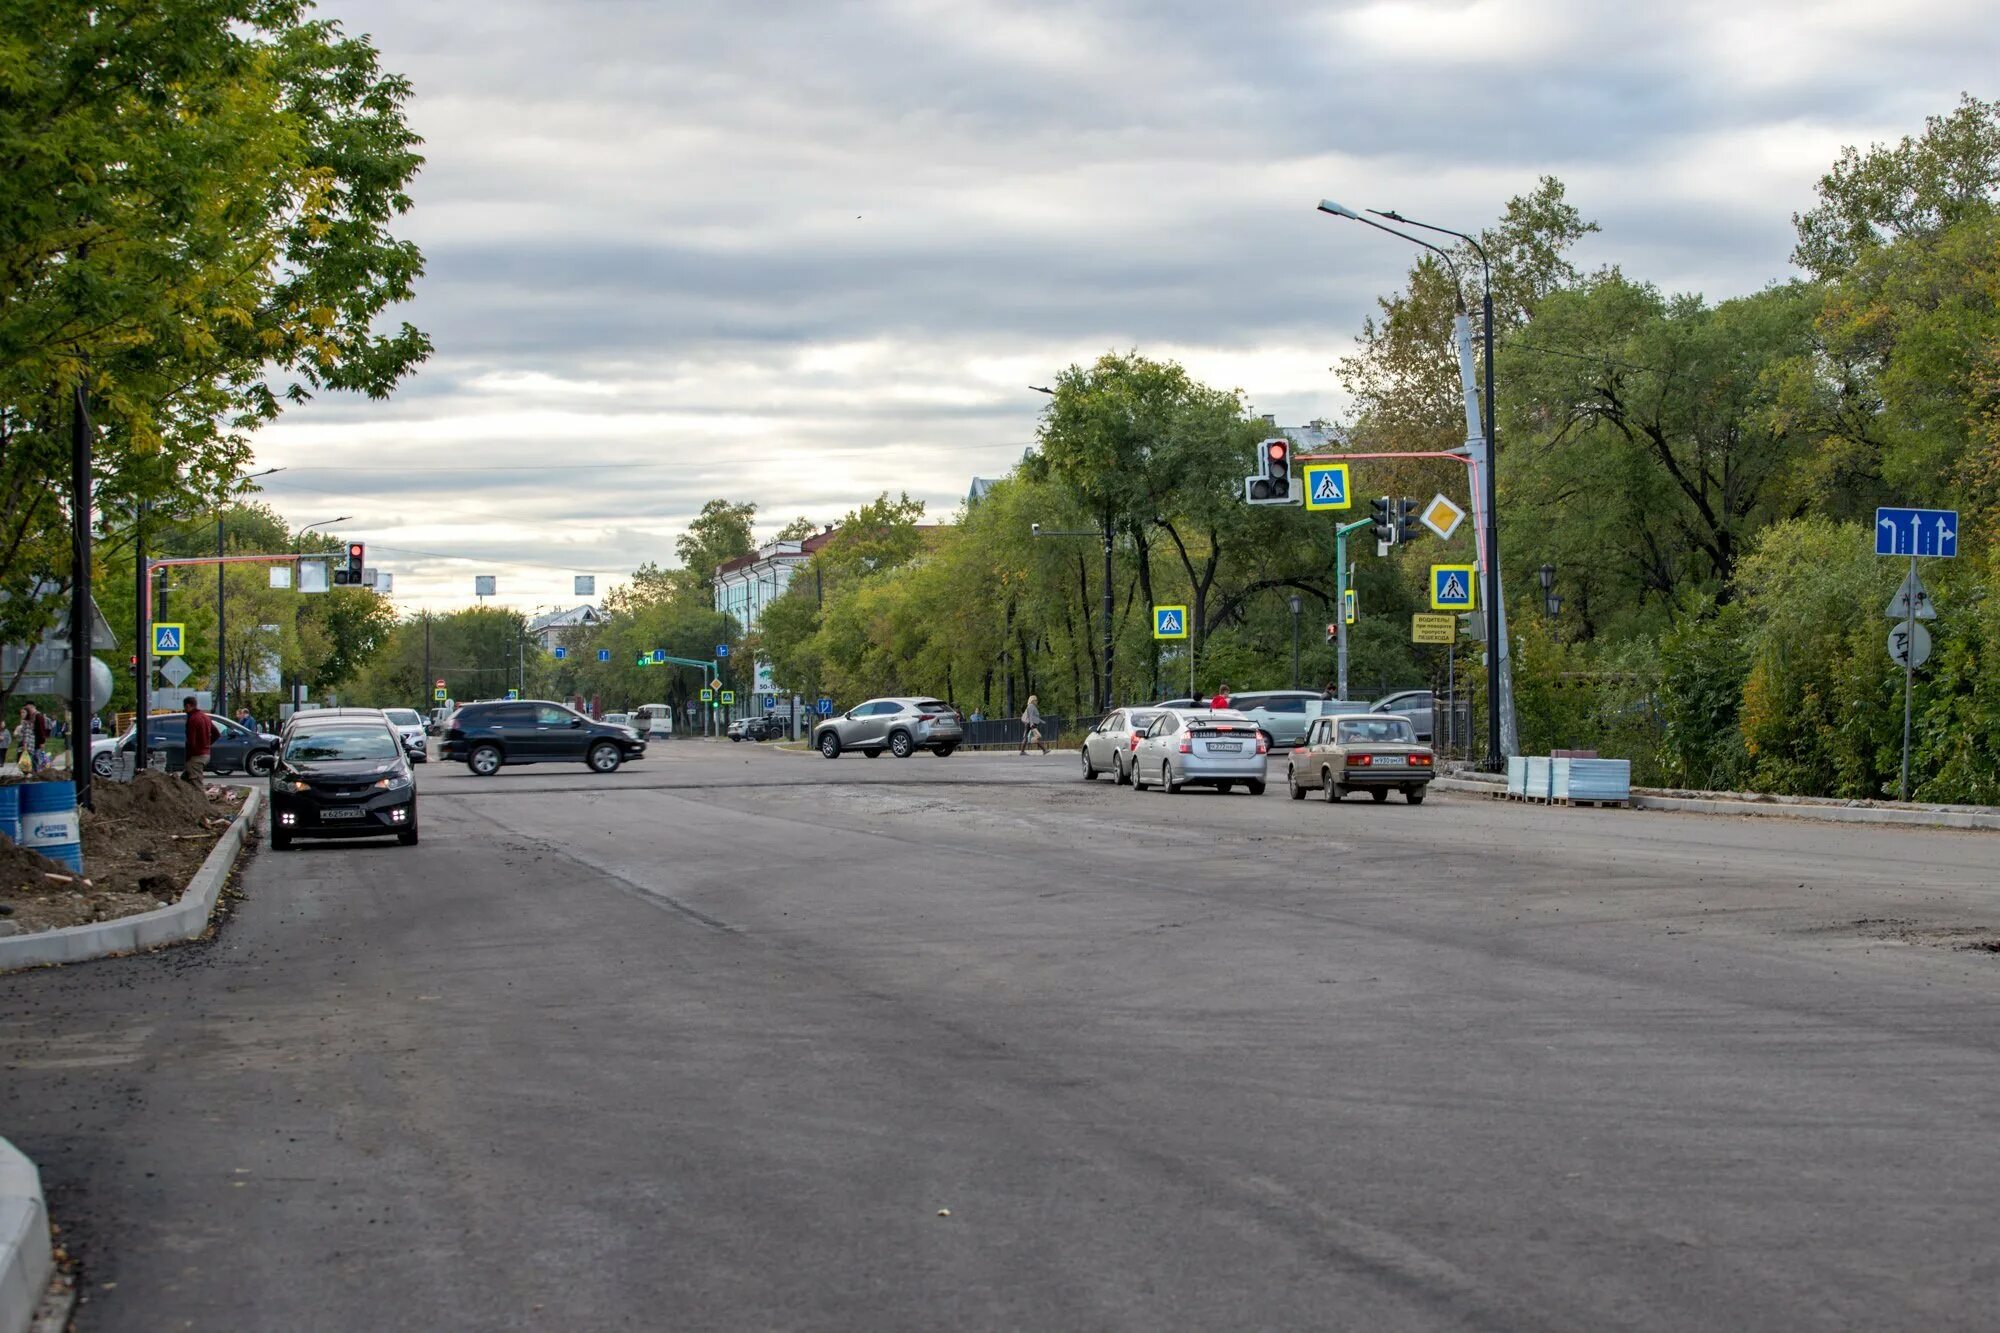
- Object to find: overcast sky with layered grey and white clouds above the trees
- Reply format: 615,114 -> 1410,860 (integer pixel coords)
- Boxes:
260,0 -> 2000,610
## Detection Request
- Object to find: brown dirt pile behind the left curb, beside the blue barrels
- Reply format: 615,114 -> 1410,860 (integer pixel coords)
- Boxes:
0,773 -> 242,935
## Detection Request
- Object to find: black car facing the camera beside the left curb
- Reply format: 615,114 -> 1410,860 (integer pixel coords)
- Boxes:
270,715 -> 416,851
